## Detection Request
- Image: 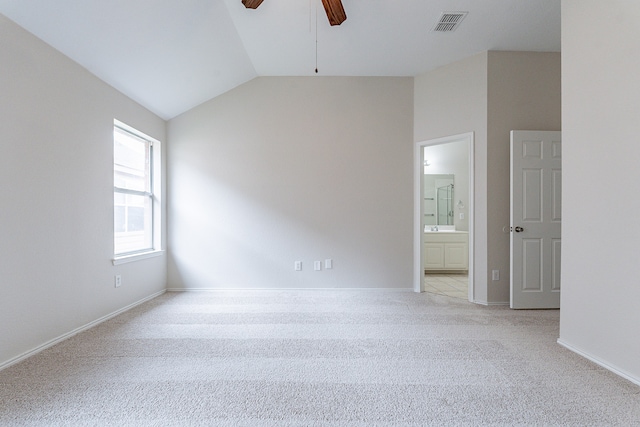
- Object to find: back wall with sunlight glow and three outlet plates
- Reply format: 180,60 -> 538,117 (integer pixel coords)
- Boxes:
168,77 -> 413,289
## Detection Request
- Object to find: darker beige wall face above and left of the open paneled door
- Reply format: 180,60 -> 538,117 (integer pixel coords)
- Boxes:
487,52 -> 561,302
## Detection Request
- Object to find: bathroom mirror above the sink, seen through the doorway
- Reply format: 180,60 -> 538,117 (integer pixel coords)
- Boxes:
423,174 -> 455,225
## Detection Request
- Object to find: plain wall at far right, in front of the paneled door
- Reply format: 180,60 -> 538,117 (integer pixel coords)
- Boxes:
560,0 -> 640,384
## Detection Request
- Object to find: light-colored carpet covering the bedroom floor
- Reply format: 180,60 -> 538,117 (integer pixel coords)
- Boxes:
0,290 -> 640,427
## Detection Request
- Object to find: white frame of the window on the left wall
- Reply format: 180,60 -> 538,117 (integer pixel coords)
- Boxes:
112,119 -> 163,265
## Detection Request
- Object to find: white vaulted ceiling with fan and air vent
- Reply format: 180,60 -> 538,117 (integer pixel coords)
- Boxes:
0,0 -> 560,119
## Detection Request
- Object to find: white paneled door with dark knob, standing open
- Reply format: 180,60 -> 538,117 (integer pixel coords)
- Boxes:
511,131 -> 562,309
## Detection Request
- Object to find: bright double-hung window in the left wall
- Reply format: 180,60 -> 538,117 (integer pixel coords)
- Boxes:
113,121 -> 159,257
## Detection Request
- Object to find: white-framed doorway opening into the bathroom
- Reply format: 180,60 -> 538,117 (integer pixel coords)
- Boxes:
414,132 -> 474,302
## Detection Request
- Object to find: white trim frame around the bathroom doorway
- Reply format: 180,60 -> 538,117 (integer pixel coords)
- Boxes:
413,132 -> 475,302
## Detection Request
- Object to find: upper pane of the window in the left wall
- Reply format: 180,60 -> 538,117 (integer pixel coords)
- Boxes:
113,127 -> 151,192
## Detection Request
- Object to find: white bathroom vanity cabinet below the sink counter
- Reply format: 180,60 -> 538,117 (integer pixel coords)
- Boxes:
423,231 -> 469,270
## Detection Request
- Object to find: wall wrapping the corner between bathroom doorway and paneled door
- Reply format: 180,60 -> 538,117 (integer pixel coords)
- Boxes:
414,51 -> 561,304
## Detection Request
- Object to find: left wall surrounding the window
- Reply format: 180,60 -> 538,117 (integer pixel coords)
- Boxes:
0,15 -> 166,367
